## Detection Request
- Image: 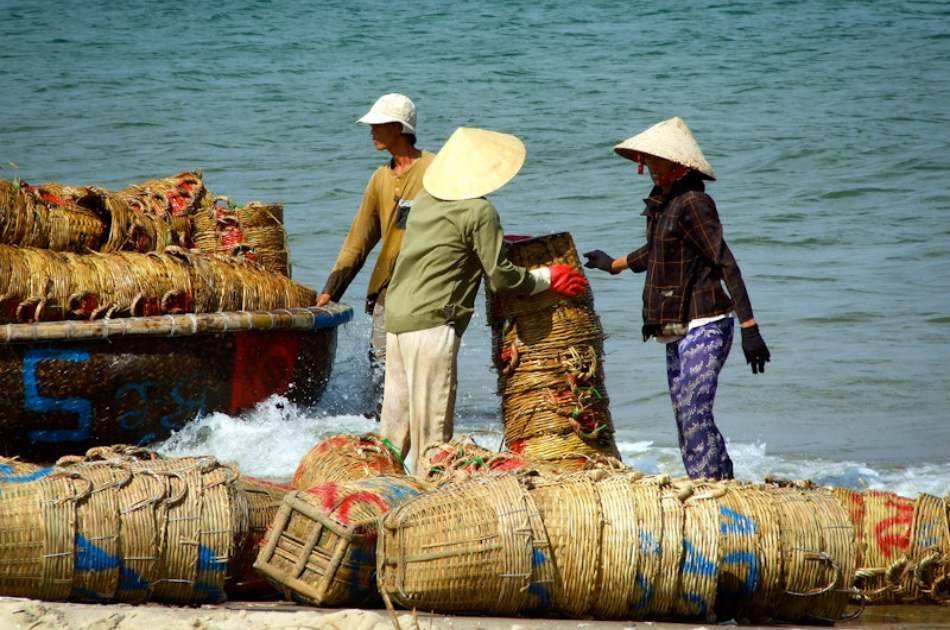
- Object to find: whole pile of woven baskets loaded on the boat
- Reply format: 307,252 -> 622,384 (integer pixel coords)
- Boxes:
0,171 -> 300,322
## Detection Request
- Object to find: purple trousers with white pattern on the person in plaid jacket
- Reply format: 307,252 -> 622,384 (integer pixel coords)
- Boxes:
666,317 -> 733,479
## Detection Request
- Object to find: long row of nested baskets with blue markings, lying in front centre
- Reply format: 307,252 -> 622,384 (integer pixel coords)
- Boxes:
377,471 -> 855,621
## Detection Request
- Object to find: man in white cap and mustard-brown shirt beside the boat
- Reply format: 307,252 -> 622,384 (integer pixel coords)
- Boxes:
317,94 -> 435,412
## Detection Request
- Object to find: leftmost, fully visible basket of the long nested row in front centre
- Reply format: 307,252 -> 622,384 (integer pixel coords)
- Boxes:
377,476 -> 544,615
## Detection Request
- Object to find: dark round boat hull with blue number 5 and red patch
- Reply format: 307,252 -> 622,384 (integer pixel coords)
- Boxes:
0,304 -> 353,459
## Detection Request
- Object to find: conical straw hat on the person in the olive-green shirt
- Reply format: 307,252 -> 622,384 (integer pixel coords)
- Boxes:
422,127 -> 526,201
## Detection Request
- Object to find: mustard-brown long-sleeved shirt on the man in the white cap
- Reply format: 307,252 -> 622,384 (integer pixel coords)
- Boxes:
323,151 -> 435,311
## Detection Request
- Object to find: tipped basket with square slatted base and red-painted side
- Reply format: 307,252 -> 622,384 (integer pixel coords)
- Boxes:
254,476 -> 428,606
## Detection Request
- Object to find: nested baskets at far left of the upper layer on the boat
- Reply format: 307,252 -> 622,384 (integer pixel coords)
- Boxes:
0,180 -> 106,252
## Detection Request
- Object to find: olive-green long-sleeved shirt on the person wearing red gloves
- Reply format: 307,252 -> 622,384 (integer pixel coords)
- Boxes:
386,191 -> 536,336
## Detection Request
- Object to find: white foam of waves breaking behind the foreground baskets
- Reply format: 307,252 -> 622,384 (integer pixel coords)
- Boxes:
159,396 -> 950,497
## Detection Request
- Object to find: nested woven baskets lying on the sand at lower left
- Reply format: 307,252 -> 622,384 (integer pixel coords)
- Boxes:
0,447 -> 272,604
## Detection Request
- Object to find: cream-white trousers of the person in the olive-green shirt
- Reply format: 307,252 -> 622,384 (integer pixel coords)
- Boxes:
379,325 -> 461,469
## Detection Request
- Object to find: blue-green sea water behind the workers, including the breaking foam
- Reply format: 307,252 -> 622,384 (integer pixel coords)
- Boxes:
0,0 -> 950,495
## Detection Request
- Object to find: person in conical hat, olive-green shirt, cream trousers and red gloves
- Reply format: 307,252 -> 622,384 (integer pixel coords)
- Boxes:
380,127 -> 587,470
